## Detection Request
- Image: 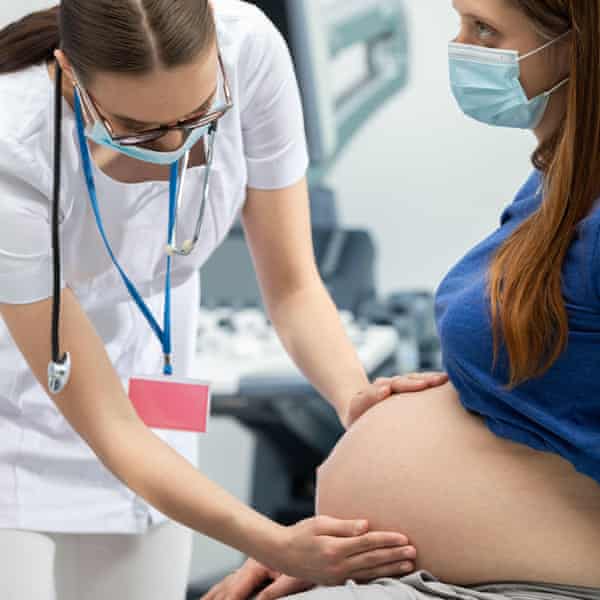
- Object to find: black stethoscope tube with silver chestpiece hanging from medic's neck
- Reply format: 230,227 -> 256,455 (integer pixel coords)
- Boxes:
48,61 -> 71,394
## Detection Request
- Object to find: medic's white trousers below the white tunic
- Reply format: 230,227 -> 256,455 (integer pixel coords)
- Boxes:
0,522 -> 192,600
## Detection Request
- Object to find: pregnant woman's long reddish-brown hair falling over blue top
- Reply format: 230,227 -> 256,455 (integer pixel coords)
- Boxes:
489,0 -> 600,388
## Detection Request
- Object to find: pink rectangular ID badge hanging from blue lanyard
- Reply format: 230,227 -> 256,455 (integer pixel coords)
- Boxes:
129,376 -> 210,433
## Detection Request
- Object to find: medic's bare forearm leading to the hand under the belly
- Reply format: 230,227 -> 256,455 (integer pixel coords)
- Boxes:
94,419 -> 283,564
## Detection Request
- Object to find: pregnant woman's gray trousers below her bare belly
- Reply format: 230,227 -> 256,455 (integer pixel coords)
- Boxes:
289,571 -> 600,600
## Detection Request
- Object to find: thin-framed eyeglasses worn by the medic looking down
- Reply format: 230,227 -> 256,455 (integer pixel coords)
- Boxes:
75,53 -> 233,146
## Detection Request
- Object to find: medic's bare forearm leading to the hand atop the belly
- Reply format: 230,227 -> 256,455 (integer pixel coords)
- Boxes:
269,281 -> 368,417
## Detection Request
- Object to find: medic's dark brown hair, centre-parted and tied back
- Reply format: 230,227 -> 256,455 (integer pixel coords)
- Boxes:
0,0 -> 216,83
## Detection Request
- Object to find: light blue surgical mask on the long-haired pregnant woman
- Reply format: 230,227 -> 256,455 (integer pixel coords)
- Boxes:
449,31 -> 570,129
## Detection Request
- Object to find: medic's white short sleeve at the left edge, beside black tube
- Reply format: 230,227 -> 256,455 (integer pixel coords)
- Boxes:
0,139 -> 64,304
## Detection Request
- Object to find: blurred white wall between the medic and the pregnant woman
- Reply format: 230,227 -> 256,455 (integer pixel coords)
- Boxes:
329,0 -> 534,292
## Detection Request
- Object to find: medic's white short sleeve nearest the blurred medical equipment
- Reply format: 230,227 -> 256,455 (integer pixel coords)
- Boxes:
240,13 -> 309,189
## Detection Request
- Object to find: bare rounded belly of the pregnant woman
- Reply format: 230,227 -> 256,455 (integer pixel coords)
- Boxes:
317,384 -> 600,587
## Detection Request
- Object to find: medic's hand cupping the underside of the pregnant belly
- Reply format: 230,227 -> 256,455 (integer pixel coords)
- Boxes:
266,516 -> 417,585
